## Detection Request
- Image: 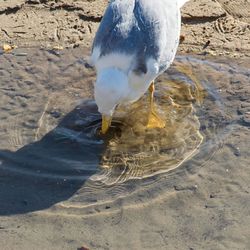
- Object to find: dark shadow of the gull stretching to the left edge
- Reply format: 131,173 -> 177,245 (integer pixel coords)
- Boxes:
0,102 -> 108,215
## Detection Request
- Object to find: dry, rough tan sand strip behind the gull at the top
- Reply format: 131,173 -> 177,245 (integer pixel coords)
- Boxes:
0,0 -> 250,57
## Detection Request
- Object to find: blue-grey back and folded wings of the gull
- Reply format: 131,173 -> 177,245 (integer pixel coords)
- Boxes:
93,1 -> 159,73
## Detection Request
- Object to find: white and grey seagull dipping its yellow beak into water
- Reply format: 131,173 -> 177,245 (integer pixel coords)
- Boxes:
90,0 -> 188,134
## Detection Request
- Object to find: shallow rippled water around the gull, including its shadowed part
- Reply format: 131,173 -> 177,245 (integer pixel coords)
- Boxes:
0,49 -> 250,215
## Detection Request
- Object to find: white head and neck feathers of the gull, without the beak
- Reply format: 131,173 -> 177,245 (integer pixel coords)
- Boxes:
92,55 -> 159,116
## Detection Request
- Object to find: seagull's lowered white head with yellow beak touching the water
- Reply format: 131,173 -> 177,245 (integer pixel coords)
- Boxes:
95,68 -> 129,134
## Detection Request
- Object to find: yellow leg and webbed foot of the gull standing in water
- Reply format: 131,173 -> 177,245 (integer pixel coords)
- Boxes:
147,82 -> 165,128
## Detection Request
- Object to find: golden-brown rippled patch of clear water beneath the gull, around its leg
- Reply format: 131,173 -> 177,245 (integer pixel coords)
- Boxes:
91,65 -> 206,185
